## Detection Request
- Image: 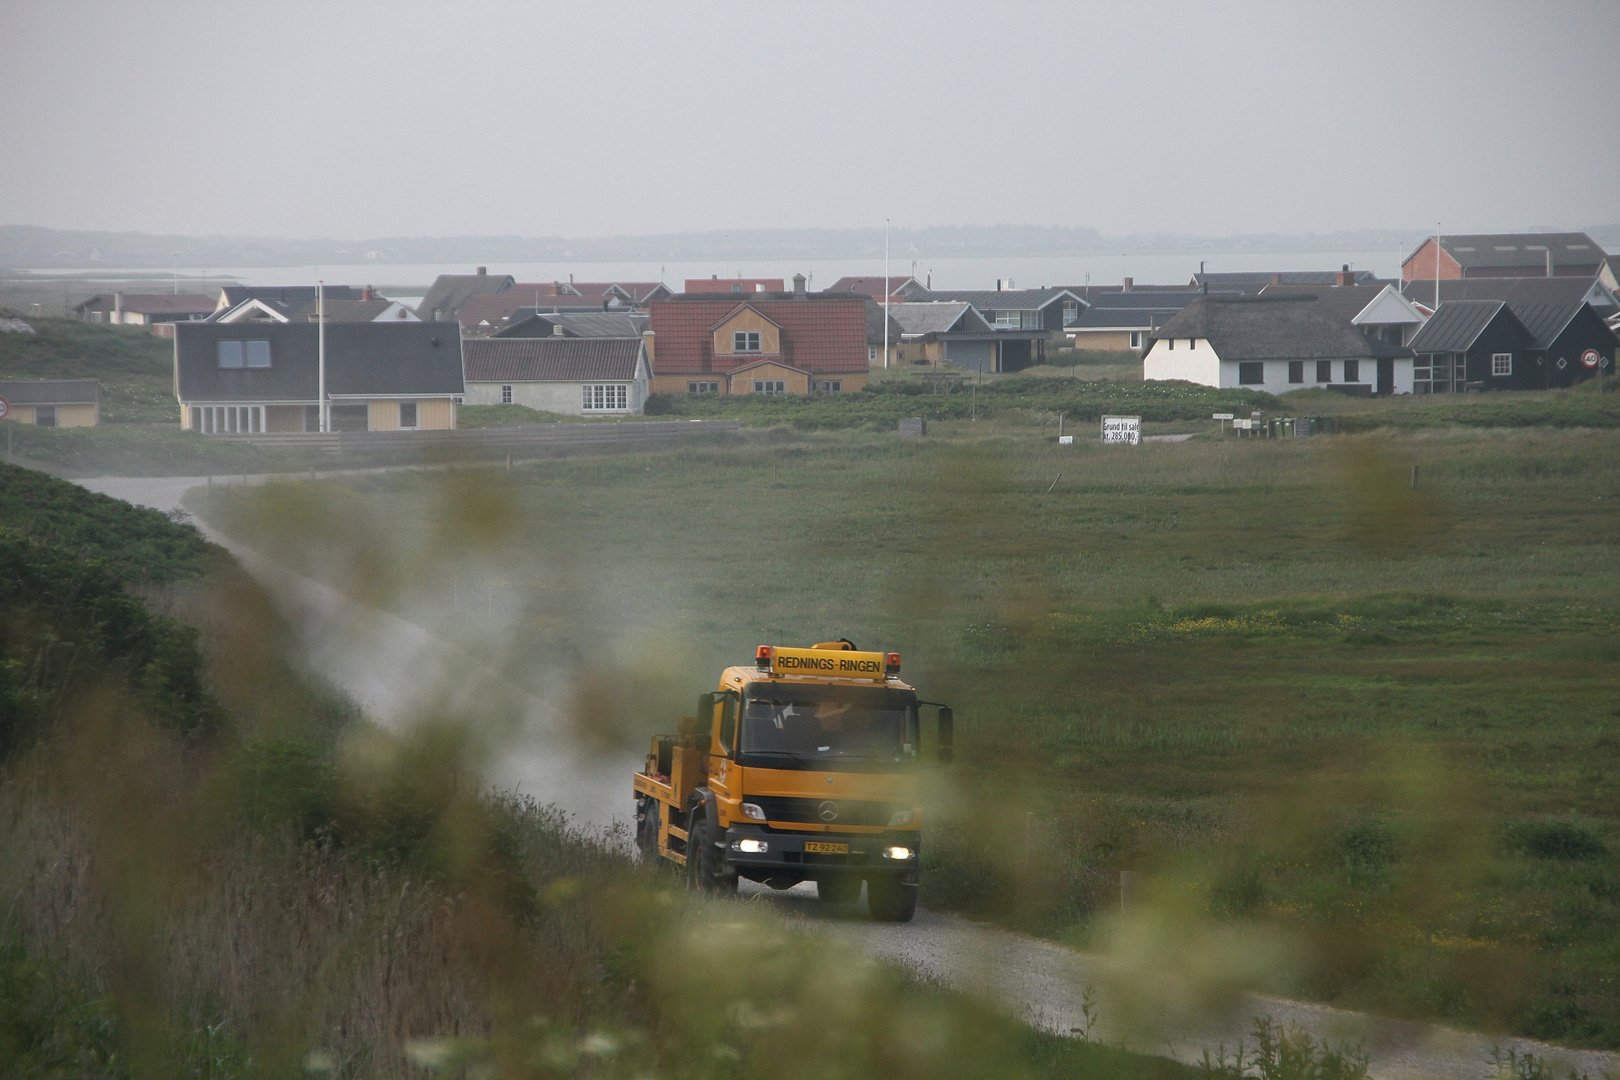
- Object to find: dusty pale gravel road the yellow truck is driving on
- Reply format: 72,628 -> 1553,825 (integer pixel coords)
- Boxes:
79,476 -> 1620,1080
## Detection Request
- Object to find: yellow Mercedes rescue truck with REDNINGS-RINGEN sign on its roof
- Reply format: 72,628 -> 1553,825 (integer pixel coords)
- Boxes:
635,640 -> 954,923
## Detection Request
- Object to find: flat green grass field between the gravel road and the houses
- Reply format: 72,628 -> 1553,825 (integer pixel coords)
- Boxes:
199,413 -> 1620,1046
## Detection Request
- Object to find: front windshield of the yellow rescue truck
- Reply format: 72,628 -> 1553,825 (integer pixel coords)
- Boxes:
737,683 -> 917,771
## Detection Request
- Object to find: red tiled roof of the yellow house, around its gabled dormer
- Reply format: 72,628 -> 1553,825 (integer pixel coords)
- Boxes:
650,293 -> 867,374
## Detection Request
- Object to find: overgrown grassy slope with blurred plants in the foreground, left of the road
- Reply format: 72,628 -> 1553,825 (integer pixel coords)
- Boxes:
0,470 -> 1189,1080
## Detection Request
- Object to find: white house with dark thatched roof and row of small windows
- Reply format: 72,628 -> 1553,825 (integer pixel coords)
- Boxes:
1142,295 -> 1413,395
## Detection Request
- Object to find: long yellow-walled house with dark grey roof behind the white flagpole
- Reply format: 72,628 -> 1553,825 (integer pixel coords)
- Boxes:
175,322 -> 465,436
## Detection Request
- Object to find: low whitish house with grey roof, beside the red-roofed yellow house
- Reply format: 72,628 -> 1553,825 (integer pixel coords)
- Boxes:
462,337 -> 653,416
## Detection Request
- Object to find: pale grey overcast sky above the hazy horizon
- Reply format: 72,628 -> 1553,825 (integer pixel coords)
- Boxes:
0,0 -> 1620,238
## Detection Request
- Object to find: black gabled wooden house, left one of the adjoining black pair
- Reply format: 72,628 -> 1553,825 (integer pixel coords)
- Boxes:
1411,300 -> 1537,393
